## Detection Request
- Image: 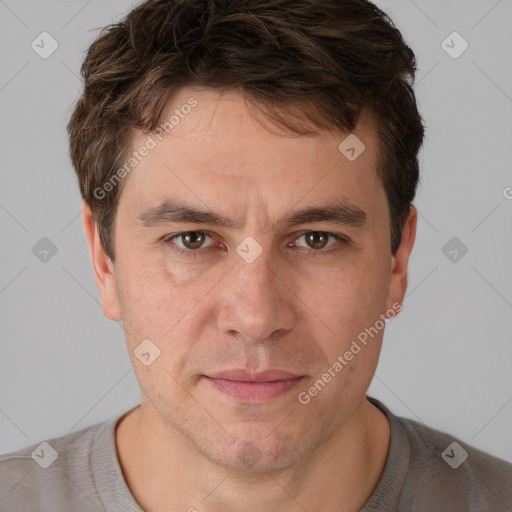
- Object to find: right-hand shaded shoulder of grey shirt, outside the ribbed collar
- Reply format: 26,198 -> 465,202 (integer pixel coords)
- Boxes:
397,418 -> 512,512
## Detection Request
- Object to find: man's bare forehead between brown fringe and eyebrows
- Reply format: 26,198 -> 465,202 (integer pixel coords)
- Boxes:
120,87 -> 383,226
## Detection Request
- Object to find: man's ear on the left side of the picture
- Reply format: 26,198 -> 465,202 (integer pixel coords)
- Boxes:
82,201 -> 121,321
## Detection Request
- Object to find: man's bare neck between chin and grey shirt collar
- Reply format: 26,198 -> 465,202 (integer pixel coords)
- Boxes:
116,400 -> 390,512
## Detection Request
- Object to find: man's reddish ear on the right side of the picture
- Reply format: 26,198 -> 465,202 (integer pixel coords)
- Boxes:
387,206 -> 418,309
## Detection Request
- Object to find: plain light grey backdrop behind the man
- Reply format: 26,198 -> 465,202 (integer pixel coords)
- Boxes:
0,0 -> 512,461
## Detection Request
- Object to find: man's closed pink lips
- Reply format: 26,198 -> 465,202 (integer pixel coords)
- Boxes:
204,369 -> 306,402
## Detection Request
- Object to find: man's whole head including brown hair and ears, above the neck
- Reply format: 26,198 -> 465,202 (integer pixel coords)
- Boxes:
68,0 -> 424,470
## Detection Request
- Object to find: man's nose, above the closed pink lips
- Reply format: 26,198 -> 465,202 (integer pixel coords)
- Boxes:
217,251 -> 296,342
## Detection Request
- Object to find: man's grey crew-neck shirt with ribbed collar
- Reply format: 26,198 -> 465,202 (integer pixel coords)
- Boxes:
0,397 -> 512,512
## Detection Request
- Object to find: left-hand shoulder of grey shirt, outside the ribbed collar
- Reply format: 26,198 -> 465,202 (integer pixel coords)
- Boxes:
0,421 -> 112,512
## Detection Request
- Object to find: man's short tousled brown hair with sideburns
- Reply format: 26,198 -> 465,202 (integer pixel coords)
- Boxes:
67,0 -> 424,261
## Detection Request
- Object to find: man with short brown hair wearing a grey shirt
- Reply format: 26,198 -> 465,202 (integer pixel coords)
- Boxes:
0,0 -> 512,512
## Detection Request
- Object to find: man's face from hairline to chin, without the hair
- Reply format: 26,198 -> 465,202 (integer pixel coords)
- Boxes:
89,88 -> 412,471
